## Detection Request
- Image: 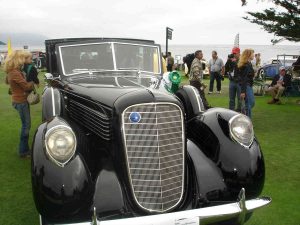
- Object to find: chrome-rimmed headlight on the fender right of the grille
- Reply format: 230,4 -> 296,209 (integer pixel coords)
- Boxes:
229,114 -> 254,148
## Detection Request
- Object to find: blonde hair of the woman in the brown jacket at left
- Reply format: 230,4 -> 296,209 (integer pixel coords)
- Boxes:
4,50 -> 25,73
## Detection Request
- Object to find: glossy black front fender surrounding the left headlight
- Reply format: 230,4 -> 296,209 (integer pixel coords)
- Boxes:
31,119 -> 93,221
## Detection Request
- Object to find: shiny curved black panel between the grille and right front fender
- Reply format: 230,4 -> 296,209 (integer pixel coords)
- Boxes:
187,140 -> 227,203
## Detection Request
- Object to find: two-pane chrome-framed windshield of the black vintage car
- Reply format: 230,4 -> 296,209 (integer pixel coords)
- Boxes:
59,42 -> 161,76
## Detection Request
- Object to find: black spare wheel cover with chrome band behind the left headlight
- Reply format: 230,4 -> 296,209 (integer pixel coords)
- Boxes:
42,87 -> 63,121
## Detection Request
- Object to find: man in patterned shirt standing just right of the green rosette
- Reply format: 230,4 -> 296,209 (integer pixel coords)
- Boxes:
190,50 -> 211,109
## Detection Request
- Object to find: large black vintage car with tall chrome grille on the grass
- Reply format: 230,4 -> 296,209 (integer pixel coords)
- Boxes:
31,38 -> 271,225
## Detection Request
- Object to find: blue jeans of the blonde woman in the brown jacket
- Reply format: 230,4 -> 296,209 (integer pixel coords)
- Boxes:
12,102 -> 31,156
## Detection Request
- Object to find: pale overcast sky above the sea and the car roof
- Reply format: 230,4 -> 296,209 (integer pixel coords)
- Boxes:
0,0 -> 295,45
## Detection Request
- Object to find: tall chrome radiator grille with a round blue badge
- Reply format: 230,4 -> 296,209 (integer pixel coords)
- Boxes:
122,103 -> 185,212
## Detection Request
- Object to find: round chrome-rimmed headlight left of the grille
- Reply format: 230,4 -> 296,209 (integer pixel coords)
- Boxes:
45,125 -> 76,166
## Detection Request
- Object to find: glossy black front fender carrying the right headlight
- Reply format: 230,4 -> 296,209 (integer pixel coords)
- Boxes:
188,108 -> 265,198
